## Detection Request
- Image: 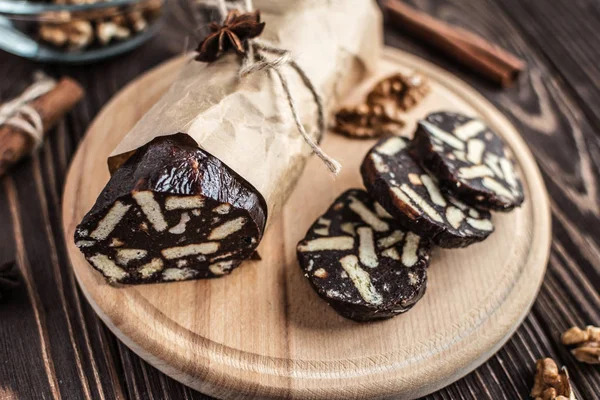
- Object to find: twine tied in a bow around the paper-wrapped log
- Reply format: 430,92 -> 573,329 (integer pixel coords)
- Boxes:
219,0 -> 342,175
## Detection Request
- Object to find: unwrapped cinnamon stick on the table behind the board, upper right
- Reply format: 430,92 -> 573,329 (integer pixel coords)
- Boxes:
384,0 -> 525,87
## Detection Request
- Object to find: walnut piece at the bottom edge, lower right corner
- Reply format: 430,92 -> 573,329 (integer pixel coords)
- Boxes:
531,358 -> 576,400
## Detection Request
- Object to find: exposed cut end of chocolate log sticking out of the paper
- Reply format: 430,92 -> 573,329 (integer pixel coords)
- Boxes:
75,133 -> 267,284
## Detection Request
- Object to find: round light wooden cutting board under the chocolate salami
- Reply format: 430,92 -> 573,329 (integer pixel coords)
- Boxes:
63,49 -> 551,400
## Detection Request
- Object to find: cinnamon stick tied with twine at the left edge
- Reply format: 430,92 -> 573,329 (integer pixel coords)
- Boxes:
0,78 -> 83,176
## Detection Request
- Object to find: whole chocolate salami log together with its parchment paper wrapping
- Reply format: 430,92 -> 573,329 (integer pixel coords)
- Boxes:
75,0 -> 382,283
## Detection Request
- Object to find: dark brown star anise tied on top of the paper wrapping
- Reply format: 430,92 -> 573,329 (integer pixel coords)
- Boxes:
196,10 -> 265,62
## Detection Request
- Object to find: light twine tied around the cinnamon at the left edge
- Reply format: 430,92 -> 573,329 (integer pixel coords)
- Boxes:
0,75 -> 56,148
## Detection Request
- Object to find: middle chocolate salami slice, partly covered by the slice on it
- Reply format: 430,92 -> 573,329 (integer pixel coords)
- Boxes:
360,136 -> 494,248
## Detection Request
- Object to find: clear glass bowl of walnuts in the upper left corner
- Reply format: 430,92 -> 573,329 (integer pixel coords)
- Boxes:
0,0 -> 167,63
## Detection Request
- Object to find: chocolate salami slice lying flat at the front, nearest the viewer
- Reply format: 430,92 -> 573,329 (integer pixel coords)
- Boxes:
297,189 -> 429,321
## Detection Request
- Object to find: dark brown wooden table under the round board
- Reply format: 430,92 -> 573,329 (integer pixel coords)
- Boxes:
0,0 -> 600,400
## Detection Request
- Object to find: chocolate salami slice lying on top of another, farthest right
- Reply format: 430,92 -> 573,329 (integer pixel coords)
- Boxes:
414,112 -> 524,211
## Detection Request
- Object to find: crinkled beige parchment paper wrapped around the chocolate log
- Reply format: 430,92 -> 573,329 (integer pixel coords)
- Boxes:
108,0 -> 382,225
